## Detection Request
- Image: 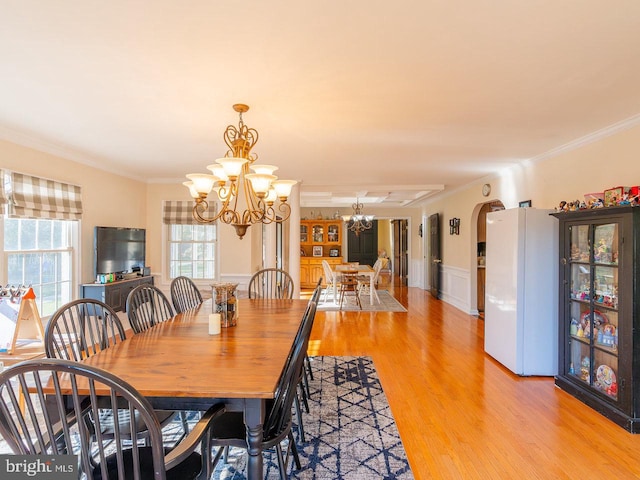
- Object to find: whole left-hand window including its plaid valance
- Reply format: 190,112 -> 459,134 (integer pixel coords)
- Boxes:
0,170 -> 82,317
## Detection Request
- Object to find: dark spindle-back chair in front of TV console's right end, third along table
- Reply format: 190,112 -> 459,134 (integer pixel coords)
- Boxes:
127,285 -> 175,333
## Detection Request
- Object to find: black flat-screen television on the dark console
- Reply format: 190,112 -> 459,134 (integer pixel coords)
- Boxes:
93,227 -> 146,275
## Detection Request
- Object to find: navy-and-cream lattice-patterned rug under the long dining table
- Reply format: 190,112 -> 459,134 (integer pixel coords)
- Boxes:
214,357 -> 413,480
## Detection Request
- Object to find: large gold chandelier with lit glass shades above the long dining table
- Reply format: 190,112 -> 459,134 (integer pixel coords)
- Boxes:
183,103 -> 297,239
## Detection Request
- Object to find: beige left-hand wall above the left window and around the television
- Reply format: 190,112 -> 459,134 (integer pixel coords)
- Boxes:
0,140 -> 147,284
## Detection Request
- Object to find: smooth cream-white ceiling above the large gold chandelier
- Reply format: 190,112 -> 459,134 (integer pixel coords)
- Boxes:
0,0 -> 640,206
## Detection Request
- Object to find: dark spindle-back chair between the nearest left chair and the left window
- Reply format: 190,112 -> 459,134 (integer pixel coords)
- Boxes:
44,298 -> 181,438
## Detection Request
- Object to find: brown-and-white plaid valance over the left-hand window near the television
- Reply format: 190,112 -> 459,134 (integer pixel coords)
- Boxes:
9,172 -> 82,220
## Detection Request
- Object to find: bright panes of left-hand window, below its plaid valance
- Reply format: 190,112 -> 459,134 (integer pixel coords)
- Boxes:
3,217 -> 77,317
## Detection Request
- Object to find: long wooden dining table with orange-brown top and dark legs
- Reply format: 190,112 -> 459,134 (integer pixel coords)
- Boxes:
70,299 -> 308,480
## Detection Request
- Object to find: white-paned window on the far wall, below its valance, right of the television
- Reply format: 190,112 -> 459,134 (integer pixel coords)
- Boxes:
167,224 -> 217,280
